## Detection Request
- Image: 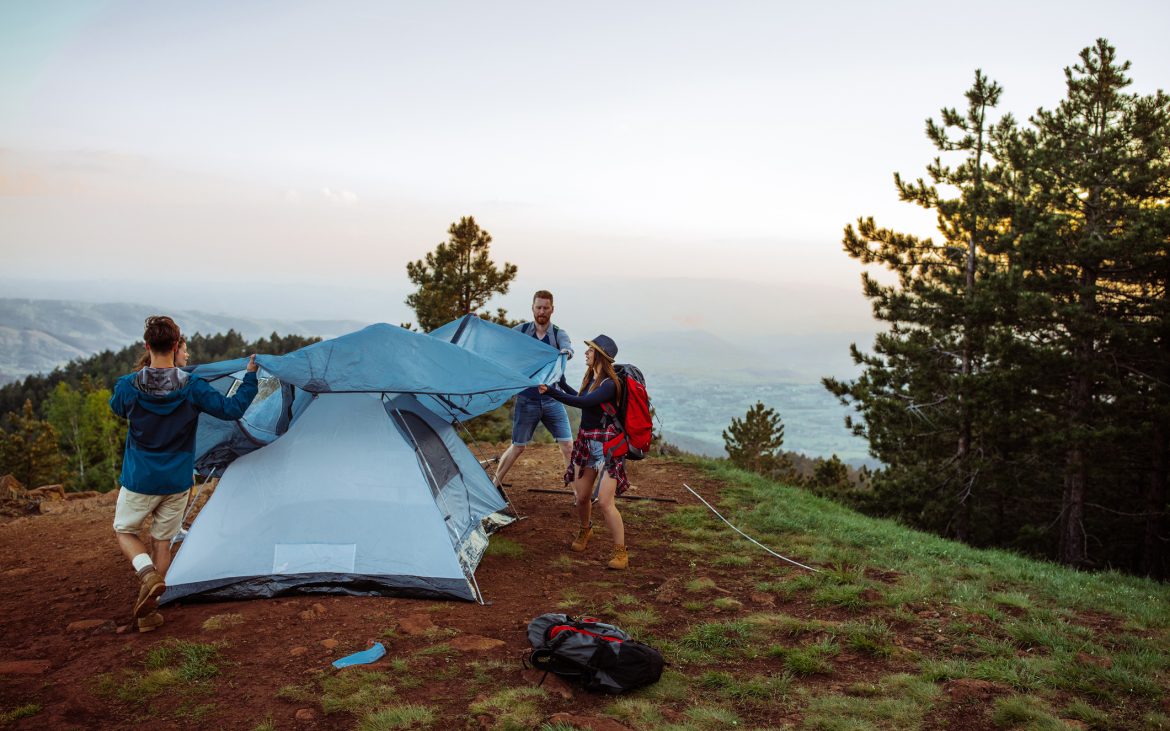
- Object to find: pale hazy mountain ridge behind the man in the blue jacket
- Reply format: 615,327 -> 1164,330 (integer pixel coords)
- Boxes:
0,298 -> 369,384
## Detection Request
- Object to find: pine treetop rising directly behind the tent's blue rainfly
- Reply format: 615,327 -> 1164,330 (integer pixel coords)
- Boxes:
406,216 -> 517,332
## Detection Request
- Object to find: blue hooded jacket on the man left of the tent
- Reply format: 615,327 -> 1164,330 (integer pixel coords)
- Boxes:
110,368 -> 257,495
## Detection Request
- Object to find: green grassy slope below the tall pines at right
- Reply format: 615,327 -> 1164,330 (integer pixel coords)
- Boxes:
650,460 -> 1170,730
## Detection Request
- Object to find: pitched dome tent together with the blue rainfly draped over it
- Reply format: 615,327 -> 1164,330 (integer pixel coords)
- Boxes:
161,324 -> 538,602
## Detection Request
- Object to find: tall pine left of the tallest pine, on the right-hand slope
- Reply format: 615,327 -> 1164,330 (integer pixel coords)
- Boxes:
824,71 -> 1014,540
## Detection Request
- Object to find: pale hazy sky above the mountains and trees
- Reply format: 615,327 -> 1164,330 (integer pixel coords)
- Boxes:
0,0 -> 1170,319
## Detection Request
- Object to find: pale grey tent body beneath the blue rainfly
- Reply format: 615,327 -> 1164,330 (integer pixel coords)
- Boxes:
161,393 -> 512,604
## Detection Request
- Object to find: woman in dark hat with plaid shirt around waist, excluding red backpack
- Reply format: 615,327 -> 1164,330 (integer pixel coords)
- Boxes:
541,335 -> 629,570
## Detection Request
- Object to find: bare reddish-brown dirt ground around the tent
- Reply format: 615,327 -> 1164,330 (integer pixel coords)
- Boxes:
0,446 -> 996,730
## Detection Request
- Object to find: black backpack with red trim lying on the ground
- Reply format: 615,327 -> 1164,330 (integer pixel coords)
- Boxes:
528,614 -> 663,694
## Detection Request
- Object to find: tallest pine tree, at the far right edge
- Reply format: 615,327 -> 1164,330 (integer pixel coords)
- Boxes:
1013,39 -> 1170,566
